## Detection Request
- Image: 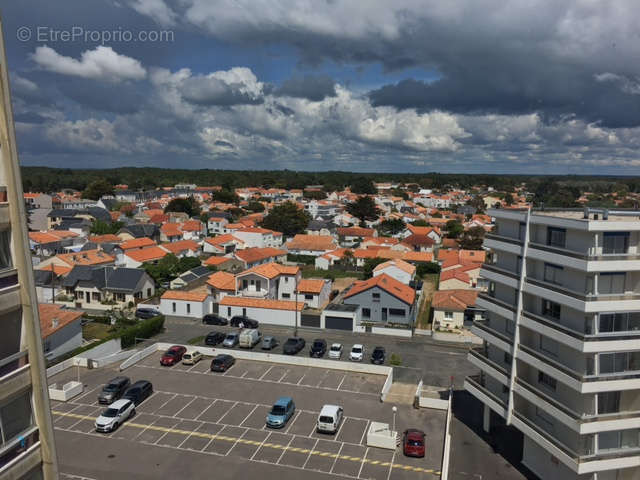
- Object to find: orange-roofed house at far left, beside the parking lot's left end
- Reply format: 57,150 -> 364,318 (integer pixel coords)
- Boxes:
38,303 -> 84,360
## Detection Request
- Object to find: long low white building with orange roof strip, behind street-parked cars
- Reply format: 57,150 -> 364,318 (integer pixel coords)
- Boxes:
218,295 -> 306,327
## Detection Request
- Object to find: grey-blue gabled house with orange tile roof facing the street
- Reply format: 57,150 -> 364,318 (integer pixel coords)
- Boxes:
343,273 -> 416,325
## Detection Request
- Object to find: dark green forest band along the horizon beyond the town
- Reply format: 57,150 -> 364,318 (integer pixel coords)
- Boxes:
22,166 -> 640,207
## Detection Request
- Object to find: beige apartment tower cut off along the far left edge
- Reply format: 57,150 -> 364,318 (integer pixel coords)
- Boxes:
0,15 -> 57,480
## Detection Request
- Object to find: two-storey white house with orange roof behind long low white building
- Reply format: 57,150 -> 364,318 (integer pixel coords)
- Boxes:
236,263 -> 302,300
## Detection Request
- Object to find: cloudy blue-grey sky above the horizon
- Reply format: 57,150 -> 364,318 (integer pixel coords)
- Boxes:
0,0 -> 640,175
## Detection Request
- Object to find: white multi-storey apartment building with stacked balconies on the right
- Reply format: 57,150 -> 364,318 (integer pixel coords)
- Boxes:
465,209 -> 640,480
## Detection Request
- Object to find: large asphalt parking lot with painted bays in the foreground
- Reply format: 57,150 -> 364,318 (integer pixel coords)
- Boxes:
50,352 -> 445,480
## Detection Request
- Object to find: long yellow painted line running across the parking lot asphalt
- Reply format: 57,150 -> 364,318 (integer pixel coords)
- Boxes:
51,410 -> 440,475
